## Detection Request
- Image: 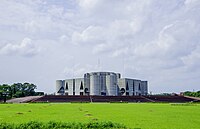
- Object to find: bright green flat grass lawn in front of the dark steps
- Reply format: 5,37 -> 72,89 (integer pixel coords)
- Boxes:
0,103 -> 200,129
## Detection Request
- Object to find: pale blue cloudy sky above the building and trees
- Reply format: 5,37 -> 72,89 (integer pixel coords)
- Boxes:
0,0 -> 200,93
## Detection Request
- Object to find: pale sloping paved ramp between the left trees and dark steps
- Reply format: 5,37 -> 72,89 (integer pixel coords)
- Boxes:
6,96 -> 42,103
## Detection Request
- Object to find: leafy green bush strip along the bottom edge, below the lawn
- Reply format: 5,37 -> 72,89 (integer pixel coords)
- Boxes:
0,121 -> 126,129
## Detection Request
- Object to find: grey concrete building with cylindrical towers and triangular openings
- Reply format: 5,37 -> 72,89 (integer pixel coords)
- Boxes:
56,72 -> 148,96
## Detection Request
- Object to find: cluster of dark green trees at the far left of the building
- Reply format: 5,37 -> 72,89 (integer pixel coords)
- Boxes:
0,82 -> 43,98
